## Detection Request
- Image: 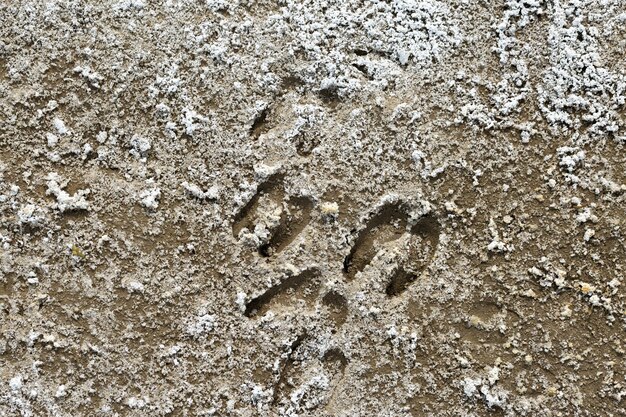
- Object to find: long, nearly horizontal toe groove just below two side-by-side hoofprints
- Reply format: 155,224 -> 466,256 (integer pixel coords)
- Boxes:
244,269 -> 319,317
